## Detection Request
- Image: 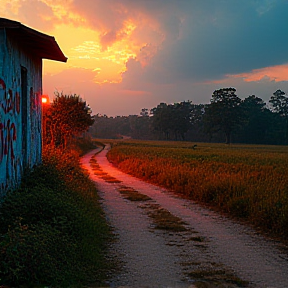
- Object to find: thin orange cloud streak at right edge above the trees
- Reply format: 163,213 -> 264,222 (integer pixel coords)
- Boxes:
228,64 -> 288,82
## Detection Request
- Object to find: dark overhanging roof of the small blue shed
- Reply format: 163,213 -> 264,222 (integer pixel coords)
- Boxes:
0,18 -> 67,62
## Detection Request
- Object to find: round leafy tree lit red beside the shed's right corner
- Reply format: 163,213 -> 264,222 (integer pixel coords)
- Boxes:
44,93 -> 94,148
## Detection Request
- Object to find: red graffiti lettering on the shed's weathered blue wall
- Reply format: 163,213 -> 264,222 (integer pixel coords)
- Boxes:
0,78 -> 20,164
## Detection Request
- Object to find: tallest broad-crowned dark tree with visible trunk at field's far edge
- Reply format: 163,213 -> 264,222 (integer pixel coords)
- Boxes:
203,88 -> 245,144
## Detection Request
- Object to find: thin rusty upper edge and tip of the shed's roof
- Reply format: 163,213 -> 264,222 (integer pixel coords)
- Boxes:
0,18 -> 68,62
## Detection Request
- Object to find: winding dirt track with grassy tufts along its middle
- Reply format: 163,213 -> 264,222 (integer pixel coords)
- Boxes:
81,147 -> 288,288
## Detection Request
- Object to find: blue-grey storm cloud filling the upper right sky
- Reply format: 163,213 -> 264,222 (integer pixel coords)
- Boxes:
143,0 -> 288,81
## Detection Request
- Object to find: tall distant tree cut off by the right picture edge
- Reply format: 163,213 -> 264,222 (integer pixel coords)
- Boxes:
269,90 -> 288,144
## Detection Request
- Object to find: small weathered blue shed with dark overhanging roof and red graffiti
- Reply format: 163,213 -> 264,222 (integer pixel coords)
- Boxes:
0,18 -> 67,199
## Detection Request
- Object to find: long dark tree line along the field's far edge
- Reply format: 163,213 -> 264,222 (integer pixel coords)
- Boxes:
90,88 -> 288,145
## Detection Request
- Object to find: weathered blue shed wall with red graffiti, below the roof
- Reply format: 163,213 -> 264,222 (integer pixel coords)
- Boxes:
0,29 -> 42,198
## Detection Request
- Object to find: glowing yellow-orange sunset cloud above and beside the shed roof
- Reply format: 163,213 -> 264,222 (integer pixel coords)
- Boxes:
0,0 -> 165,84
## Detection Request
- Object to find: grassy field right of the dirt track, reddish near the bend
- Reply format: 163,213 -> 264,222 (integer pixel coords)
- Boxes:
108,141 -> 288,239
